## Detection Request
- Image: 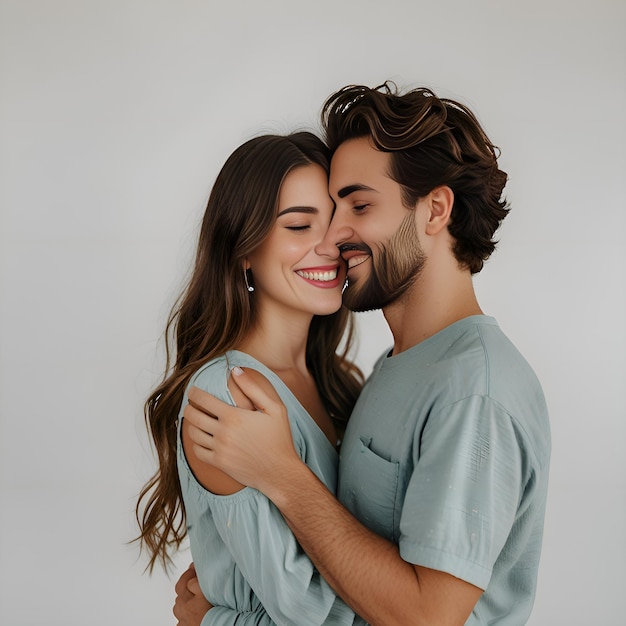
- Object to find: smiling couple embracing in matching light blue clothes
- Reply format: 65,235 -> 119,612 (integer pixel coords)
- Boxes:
137,84 -> 550,626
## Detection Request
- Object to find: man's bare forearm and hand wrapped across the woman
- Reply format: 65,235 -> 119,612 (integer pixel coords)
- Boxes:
185,374 -> 482,626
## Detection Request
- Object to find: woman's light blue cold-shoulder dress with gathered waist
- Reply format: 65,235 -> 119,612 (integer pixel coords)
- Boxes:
177,351 -> 364,626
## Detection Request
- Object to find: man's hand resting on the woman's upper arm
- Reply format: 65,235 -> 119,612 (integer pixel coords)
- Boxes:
184,368 -> 301,497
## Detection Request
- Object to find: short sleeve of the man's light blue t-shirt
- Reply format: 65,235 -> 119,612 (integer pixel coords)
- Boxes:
400,396 -> 526,589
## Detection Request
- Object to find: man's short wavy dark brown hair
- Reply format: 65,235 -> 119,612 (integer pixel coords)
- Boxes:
322,82 -> 509,274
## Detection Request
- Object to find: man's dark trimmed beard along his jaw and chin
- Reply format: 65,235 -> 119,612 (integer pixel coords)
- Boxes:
343,211 -> 426,312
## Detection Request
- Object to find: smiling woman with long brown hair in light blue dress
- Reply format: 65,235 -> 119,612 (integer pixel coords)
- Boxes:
137,133 -> 361,625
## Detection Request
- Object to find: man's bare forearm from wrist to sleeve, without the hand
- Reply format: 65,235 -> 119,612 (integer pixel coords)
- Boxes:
267,454 -> 482,626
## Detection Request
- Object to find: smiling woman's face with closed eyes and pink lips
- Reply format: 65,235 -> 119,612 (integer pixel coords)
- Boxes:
247,165 -> 346,315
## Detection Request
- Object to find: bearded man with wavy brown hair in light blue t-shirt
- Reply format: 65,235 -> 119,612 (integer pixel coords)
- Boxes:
178,85 -> 550,626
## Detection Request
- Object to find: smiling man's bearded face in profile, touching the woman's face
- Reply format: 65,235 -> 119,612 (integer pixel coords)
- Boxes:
324,137 -> 425,311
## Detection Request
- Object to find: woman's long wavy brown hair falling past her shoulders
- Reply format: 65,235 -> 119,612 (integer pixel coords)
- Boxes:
136,132 -> 362,572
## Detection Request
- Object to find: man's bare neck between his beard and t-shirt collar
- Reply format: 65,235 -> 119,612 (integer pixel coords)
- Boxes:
383,260 -> 483,354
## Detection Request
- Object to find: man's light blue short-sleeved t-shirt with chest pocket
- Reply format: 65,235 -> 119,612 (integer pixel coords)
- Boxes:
338,315 -> 550,626
